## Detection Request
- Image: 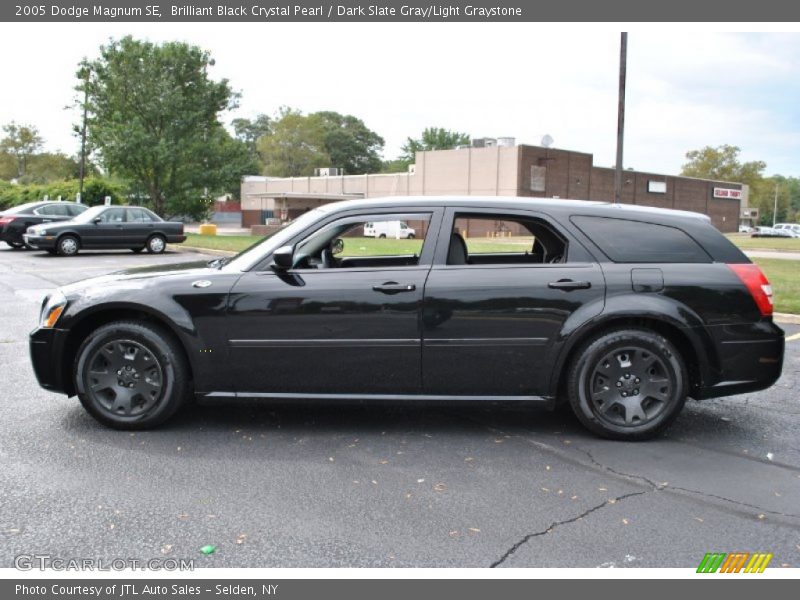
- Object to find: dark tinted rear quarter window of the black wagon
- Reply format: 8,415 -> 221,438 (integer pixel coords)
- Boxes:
570,216 -> 712,263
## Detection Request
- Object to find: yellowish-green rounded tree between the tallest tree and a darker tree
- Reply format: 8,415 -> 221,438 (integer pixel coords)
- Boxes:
258,107 -> 331,177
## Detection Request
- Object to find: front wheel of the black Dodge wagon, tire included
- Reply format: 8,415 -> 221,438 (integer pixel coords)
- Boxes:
74,321 -> 190,430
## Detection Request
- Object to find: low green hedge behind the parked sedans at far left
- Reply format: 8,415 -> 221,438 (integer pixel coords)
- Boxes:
0,177 -> 128,210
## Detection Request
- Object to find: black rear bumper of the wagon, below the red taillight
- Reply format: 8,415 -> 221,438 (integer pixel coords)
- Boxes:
692,322 -> 785,400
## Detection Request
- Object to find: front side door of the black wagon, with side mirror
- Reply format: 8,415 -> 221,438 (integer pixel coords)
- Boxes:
226,208 -> 441,397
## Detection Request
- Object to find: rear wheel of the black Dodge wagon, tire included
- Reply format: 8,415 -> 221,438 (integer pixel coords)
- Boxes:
567,329 -> 689,440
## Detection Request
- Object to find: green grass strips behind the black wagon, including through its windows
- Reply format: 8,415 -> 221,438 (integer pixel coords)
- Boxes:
184,233 -> 800,314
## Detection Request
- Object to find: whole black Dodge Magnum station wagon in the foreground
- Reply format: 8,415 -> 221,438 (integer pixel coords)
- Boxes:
30,197 -> 784,439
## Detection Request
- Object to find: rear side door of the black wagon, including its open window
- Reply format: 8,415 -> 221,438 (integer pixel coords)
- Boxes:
422,208 -> 605,397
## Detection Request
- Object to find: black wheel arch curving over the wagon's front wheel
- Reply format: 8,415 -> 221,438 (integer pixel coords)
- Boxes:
60,304 -> 194,396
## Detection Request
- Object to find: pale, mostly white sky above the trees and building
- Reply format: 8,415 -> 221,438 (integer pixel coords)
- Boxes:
0,23 -> 800,176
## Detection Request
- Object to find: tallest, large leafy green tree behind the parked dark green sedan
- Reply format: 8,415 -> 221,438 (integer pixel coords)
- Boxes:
82,36 -> 252,218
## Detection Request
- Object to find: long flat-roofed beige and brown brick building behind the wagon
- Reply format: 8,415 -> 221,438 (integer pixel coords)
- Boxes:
241,138 -> 747,232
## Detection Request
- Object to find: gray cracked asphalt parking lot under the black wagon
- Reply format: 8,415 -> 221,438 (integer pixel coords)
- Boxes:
0,244 -> 800,568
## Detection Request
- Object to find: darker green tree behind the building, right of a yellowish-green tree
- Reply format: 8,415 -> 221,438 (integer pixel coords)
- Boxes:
309,111 -> 384,175
